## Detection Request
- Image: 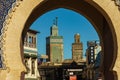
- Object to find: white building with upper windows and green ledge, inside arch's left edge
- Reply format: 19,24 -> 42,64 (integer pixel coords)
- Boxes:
24,30 -> 39,80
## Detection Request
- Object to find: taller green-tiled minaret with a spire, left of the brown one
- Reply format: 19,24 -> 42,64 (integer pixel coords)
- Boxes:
46,19 -> 63,63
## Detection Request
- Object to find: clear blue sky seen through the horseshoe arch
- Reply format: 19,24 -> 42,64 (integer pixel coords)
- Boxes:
30,8 -> 99,59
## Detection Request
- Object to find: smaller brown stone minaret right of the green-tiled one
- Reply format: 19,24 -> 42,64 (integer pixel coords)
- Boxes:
72,33 -> 83,62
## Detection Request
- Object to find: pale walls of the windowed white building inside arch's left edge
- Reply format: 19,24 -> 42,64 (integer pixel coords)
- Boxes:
24,29 -> 39,80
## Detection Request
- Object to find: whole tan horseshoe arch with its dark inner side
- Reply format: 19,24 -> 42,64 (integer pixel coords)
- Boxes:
0,0 -> 120,80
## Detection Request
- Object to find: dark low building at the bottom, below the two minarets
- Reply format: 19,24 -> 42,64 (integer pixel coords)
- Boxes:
38,59 -> 86,80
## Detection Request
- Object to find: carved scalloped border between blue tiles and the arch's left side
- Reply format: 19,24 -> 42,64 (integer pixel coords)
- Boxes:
0,0 -> 21,69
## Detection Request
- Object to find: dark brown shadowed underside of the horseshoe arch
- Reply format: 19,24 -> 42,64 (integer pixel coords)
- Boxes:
22,0 -> 117,80
